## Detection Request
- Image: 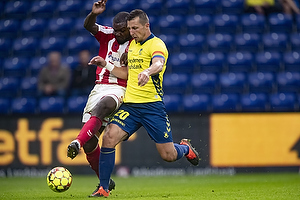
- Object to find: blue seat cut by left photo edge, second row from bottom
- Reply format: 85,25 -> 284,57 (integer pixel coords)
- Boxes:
0,77 -> 20,98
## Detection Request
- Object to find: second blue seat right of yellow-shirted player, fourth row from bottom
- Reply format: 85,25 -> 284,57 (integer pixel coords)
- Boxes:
177,34 -> 206,53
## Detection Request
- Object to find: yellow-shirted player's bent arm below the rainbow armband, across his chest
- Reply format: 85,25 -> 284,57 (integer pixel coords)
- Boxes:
138,57 -> 165,86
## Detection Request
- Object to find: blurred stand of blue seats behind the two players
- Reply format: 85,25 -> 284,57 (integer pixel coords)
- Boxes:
0,0 -> 300,114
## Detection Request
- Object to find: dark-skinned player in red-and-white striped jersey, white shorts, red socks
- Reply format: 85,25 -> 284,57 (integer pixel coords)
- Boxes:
67,0 -> 132,195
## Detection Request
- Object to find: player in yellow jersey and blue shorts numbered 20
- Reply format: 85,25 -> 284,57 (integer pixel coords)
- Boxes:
90,9 -> 199,196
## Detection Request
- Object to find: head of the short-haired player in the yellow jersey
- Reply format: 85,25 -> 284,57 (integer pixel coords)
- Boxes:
127,9 -> 151,42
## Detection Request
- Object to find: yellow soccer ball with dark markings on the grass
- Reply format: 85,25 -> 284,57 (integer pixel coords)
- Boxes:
47,167 -> 72,192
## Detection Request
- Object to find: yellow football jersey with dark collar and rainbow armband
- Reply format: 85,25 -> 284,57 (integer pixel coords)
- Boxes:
124,34 -> 168,103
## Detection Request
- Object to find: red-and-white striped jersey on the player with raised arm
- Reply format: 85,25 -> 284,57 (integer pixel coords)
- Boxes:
94,25 -> 130,87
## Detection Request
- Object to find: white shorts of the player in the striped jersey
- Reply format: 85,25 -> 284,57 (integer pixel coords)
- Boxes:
82,84 -> 126,126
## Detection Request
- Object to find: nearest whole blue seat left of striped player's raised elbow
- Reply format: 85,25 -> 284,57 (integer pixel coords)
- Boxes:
48,17 -> 74,37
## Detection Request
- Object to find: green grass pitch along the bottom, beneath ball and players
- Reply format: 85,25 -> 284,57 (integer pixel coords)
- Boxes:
0,173 -> 300,200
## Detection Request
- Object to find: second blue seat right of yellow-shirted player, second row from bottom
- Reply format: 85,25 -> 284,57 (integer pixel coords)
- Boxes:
191,72 -> 219,94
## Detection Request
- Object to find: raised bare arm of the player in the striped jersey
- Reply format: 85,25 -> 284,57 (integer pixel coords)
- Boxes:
83,0 -> 107,35
